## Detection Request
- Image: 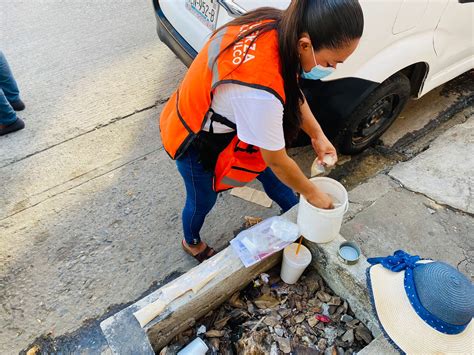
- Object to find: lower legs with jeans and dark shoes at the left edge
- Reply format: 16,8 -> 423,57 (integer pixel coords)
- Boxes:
0,51 -> 25,136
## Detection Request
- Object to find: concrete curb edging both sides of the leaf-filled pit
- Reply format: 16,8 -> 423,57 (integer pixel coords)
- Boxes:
100,206 -> 391,354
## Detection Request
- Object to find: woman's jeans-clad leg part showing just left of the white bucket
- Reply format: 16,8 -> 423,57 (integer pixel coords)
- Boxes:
257,168 -> 298,212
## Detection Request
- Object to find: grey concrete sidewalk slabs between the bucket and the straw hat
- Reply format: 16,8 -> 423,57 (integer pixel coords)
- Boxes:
341,114 -> 474,279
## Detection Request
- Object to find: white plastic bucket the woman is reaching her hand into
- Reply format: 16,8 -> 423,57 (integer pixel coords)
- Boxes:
297,177 -> 349,243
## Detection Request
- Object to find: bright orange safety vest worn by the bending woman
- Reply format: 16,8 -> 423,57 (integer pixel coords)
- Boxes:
159,22 -> 285,192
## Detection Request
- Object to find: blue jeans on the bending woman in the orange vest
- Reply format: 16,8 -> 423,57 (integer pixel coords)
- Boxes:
176,146 -> 298,245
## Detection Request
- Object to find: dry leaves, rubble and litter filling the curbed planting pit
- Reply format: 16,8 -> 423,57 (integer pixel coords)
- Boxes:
160,267 -> 373,355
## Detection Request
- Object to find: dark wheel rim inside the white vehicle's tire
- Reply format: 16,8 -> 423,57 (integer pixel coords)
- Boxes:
352,94 -> 400,146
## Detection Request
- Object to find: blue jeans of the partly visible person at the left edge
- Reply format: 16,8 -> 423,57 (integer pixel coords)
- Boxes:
0,51 -> 20,125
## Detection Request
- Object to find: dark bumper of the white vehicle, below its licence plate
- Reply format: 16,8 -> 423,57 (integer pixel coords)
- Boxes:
153,0 -> 197,67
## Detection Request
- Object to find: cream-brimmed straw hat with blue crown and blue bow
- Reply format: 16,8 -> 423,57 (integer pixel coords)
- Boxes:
367,250 -> 474,354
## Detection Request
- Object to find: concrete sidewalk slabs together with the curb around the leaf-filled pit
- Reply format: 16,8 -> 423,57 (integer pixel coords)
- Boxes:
101,112 -> 474,355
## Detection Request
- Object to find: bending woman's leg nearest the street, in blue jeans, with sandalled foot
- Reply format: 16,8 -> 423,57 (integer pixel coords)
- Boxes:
176,146 -> 217,256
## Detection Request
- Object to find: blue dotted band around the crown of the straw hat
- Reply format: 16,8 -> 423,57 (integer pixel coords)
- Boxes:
404,268 -> 469,334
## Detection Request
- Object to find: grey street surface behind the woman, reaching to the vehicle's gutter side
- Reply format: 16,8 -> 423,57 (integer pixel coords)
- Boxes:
0,0 -> 472,354
